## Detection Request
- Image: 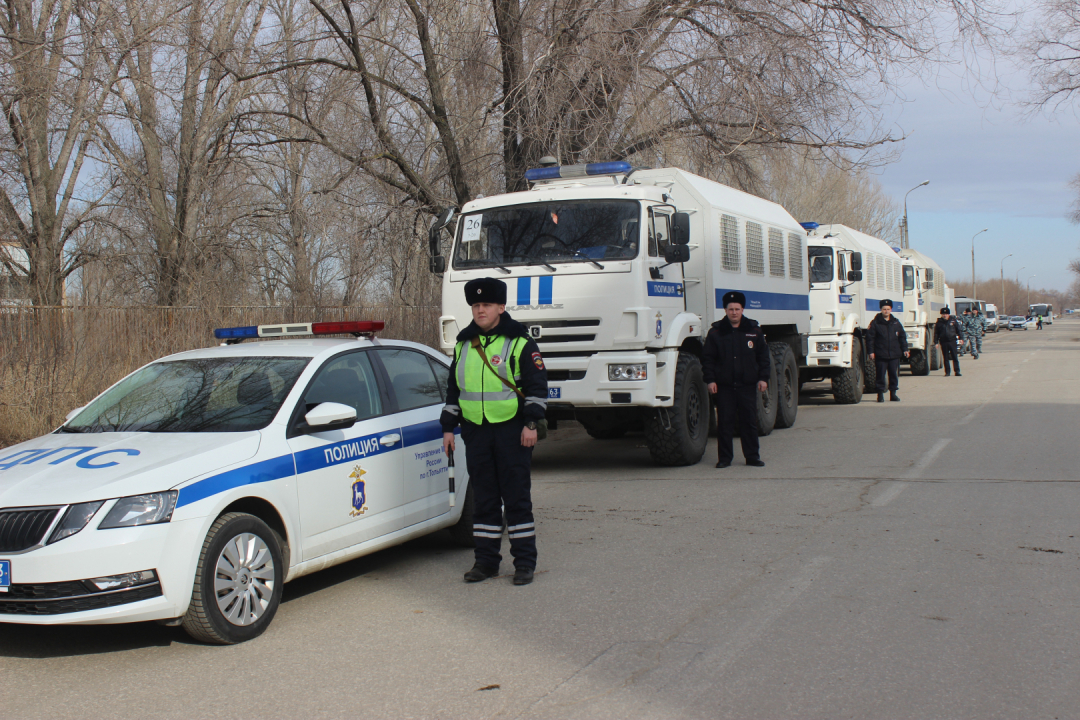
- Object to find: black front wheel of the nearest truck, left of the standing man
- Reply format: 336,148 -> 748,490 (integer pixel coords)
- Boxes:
645,353 -> 708,465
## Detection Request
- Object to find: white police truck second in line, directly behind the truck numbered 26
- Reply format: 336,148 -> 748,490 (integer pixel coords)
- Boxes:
799,223 -> 915,404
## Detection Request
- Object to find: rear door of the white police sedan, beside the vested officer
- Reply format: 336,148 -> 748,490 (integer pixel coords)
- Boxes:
375,348 -> 453,526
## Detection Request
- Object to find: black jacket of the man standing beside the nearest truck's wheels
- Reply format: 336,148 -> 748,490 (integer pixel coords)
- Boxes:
702,315 -> 771,388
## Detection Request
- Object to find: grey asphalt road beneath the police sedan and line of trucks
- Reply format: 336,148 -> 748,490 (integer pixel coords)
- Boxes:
0,320 -> 1080,720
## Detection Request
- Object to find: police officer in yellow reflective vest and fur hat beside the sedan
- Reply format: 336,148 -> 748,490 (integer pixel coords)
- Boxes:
440,277 -> 548,585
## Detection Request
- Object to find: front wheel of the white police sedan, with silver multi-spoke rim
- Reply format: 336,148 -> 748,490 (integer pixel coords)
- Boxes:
181,513 -> 285,644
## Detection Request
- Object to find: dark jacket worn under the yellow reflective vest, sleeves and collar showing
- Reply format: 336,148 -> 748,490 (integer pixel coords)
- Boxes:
438,312 -> 548,433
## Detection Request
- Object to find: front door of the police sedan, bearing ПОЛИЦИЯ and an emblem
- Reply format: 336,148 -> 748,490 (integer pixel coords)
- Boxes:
288,351 -> 404,560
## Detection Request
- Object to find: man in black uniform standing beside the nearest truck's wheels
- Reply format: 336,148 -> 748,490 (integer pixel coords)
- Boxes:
702,290 -> 771,467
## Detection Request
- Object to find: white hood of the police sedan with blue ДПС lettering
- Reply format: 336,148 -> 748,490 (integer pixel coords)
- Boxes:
0,431 -> 261,507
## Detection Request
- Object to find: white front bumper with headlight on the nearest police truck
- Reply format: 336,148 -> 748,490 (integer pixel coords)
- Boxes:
544,349 -> 678,407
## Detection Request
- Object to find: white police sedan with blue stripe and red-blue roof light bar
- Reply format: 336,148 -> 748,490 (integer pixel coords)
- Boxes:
0,322 -> 472,643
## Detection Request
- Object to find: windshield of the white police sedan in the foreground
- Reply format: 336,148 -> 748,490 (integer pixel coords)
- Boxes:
60,357 -> 311,433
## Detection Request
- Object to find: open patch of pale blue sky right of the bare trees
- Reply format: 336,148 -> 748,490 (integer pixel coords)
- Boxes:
879,52 -> 1080,301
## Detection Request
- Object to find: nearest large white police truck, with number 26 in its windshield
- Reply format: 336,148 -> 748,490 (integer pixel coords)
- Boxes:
431,162 -> 810,465
